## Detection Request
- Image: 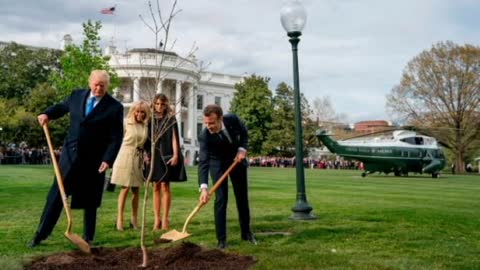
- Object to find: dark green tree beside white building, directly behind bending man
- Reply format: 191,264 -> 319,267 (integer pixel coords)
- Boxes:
230,75 -> 273,155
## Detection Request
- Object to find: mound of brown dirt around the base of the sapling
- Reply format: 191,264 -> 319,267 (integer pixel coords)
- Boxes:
25,242 -> 255,270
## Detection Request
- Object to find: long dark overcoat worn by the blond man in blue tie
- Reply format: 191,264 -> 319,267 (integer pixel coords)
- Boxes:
44,89 -> 123,208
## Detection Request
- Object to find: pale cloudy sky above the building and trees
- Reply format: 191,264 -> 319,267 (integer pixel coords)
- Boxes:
0,0 -> 480,123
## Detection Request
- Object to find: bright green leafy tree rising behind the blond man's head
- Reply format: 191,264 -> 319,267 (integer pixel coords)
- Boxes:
51,20 -> 119,100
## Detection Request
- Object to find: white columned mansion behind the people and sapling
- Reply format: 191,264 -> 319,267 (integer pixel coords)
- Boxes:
105,46 -> 243,164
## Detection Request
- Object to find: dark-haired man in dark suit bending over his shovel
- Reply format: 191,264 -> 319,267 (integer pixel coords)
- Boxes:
198,104 -> 257,249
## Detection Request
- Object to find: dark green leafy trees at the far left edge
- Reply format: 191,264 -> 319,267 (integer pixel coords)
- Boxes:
0,43 -> 61,145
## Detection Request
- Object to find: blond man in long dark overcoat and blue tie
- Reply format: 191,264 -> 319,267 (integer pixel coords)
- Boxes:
30,70 -> 123,247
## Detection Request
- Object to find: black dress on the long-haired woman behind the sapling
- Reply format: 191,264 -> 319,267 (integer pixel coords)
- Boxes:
144,116 -> 187,182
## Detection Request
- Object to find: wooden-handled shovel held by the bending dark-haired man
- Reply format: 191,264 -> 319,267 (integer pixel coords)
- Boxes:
157,159 -> 239,243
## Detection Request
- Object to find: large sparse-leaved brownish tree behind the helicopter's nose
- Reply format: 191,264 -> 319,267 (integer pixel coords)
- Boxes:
387,41 -> 480,172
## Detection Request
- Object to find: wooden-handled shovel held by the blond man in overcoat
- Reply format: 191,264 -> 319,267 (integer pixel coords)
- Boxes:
43,124 -> 90,253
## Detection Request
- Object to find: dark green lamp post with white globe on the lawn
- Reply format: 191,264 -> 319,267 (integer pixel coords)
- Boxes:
280,0 -> 315,220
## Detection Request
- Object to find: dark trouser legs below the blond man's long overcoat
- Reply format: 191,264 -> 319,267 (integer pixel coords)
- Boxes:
35,182 -> 97,242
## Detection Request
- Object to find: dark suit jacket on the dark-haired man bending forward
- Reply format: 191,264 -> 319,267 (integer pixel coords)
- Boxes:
198,113 -> 248,187
